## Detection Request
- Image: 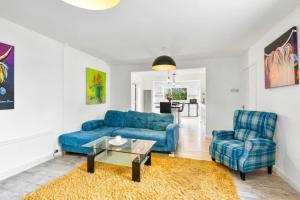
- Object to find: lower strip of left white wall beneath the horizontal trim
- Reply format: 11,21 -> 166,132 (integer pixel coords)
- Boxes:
0,132 -> 57,180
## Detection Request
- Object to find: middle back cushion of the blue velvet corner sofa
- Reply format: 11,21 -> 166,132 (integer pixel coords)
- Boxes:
126,111 -> 149,129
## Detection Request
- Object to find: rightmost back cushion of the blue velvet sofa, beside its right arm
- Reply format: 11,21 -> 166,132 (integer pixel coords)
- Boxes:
148,113 -> 174,131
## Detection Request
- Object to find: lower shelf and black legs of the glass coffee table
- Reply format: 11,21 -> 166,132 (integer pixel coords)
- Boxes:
87,150 -> 151,182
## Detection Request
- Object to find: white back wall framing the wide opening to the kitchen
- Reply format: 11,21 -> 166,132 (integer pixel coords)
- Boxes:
111,57 -> 242,135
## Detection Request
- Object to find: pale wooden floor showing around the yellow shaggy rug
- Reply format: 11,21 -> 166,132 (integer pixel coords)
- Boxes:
0,118 -> 299,200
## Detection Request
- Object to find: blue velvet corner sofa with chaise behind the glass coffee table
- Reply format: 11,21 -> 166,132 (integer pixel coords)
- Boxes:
58,110 -> 179,154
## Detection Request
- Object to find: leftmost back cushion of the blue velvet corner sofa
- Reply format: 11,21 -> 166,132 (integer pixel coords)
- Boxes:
104,110 -> 127,127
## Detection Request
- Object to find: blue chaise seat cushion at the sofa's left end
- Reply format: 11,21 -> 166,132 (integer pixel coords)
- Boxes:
59,126 -> 119,146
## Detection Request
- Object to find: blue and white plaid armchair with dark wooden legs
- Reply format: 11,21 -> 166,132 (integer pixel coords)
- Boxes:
209,110 -> 277,180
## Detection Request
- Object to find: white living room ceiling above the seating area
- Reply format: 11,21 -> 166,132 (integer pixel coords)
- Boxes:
0,0 -> 300,64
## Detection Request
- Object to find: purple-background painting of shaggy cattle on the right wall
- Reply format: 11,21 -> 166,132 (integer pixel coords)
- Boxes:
264,27 -> 299,89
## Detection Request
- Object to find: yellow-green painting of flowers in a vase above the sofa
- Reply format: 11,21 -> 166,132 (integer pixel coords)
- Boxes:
86,68 -> 106,105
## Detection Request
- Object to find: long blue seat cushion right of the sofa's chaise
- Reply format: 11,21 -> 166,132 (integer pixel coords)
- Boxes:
112,128 -> 167,146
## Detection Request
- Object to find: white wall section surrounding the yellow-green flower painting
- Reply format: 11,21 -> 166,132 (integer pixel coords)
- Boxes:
63,46 -> 110,132
